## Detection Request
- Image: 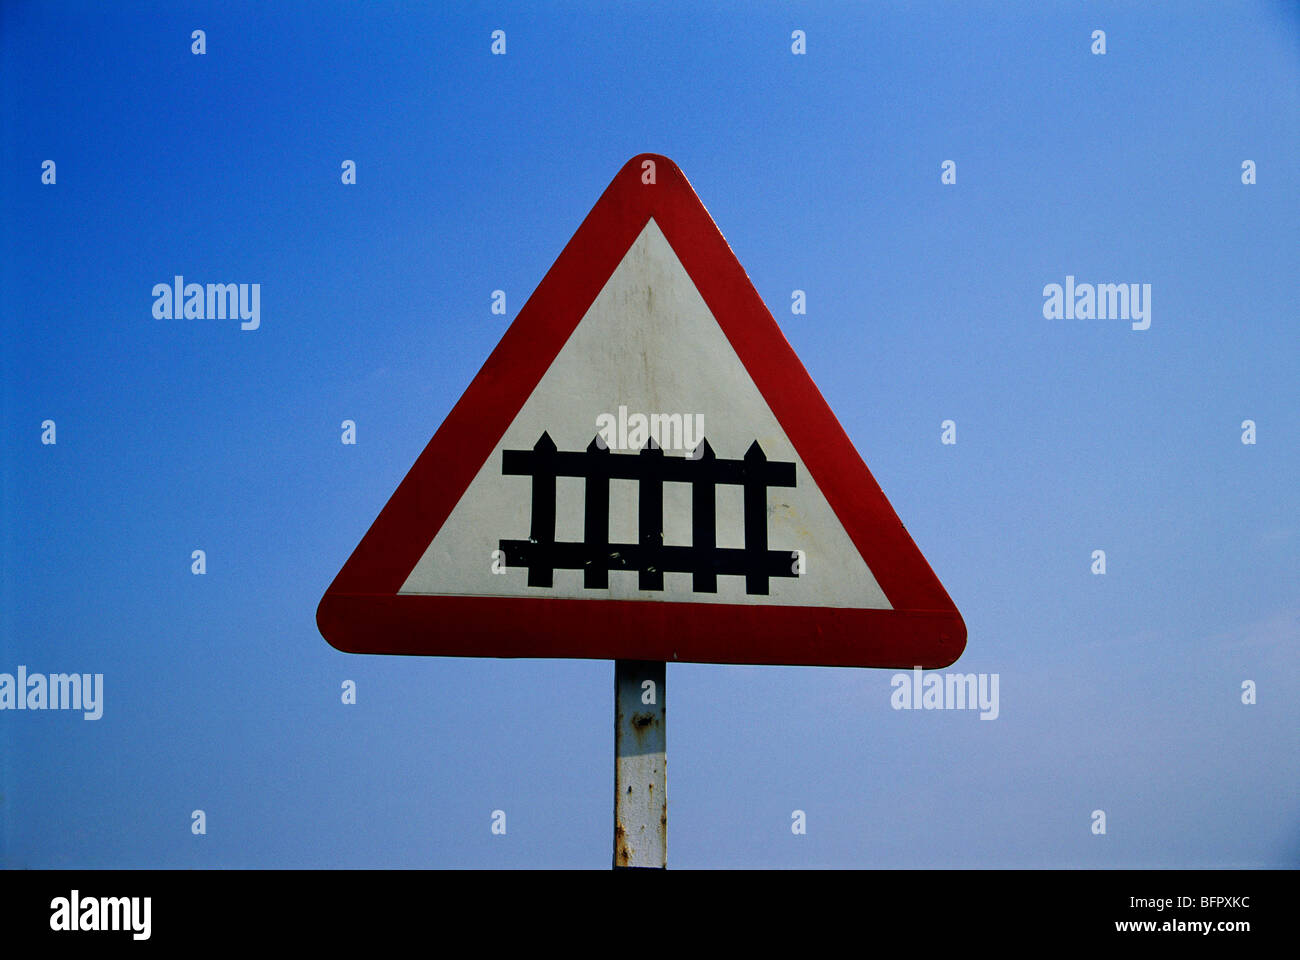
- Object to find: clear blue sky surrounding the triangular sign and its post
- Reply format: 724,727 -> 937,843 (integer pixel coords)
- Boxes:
0,3 -> 1300,869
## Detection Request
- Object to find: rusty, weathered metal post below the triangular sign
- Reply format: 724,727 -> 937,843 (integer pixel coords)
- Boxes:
614,660 -> 668,869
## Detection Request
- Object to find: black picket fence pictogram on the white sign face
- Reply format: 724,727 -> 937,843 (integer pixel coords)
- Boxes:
501,433 -> 798,594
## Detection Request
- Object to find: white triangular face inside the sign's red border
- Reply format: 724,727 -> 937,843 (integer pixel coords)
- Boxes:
399,219 -> 892,610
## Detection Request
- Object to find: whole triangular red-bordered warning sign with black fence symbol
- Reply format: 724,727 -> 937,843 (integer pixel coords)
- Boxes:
316,153 -> 966,669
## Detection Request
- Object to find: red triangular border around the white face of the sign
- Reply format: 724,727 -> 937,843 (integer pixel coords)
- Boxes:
316,153 -> 966,669
